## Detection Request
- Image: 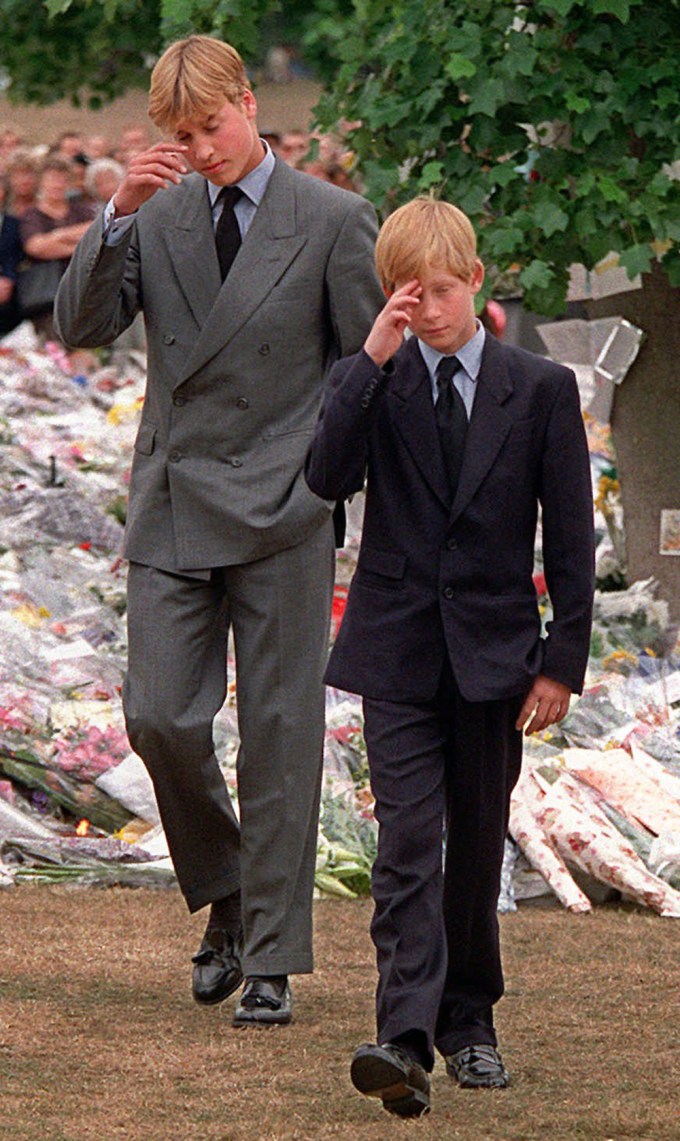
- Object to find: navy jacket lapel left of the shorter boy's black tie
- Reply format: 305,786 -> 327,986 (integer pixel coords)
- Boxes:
388,337 -> 450,507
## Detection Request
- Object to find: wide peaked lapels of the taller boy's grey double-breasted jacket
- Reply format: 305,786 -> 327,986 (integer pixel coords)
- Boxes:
176,161 -> 307,383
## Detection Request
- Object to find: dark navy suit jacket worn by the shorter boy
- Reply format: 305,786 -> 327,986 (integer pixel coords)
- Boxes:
306,334 -> 594,702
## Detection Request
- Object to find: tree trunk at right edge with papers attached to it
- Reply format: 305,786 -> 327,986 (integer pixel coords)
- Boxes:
586,265 -> 680,621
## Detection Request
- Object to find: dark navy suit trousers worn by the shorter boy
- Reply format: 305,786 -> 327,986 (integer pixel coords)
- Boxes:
364,663 -> 523,1062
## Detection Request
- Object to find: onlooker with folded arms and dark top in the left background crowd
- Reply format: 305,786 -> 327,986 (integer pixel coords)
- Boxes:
19,155 -> 94,338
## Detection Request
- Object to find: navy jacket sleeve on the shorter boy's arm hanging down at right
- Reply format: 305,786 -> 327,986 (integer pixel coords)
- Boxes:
540,374 -> 594,693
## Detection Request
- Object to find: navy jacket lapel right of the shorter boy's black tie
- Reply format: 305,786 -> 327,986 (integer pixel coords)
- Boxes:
452,333 -> 513,521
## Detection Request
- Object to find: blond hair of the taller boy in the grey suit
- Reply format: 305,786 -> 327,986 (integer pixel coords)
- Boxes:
148,35 -> 250,131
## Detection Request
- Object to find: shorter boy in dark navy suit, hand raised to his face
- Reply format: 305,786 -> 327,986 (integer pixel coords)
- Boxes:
306,199 -> 593,1117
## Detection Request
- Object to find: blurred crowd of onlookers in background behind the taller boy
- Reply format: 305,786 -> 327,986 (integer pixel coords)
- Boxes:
0,124 -> 359,340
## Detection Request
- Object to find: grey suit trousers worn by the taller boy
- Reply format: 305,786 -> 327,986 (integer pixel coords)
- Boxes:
123,520 -> 334,974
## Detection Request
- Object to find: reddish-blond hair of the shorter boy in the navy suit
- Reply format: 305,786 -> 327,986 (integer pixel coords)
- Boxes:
375,197 -> 478,291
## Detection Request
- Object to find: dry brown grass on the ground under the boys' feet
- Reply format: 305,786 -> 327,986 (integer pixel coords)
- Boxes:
0,885 -> 679,1141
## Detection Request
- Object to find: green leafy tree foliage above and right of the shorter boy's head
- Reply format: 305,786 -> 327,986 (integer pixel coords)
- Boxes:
312,0 -> 680,314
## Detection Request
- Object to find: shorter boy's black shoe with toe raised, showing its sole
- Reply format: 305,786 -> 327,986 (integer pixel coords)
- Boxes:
349,1043 -> 430,1117
